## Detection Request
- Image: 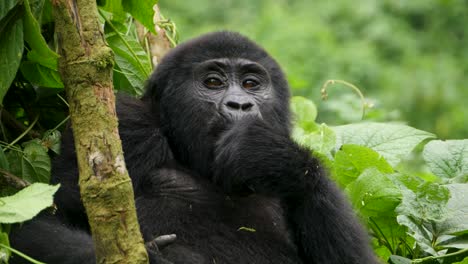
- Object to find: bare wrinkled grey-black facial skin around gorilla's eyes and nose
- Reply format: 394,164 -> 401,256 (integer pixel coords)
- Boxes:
193,58 -> 272,122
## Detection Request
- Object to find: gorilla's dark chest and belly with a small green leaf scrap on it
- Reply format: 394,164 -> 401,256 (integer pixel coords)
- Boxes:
136,170 -> 300,263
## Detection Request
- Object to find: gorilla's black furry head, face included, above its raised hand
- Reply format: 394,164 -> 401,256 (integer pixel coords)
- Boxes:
144,32 -> 290,174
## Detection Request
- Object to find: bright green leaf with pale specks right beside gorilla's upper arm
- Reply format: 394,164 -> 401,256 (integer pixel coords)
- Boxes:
345,168 -> 401,217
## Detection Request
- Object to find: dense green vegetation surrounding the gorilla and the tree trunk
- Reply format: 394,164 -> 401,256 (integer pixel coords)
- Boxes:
0,0 -> 468,264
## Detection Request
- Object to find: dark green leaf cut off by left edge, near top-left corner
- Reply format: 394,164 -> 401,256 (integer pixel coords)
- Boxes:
0,7 -> 24,105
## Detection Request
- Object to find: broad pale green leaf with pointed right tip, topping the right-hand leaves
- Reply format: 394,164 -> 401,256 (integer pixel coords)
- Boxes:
333,123 -> 434,166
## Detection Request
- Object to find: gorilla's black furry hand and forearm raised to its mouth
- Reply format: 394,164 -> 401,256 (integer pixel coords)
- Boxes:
213,117 -> 322,198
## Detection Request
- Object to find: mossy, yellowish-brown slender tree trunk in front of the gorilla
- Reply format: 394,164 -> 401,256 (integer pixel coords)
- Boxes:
51,0 -> 148,264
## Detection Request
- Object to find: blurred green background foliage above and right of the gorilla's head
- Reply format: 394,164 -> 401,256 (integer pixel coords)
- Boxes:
160,0 -> 468,138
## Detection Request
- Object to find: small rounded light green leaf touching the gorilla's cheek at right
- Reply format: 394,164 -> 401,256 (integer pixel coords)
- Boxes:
291,96 -> 317,132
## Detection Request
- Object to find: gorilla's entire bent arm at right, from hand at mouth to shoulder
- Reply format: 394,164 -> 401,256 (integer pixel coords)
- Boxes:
213,118 -> 378,264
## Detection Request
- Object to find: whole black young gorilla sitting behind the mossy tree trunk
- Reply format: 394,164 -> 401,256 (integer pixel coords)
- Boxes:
12,32 -> 377,264
